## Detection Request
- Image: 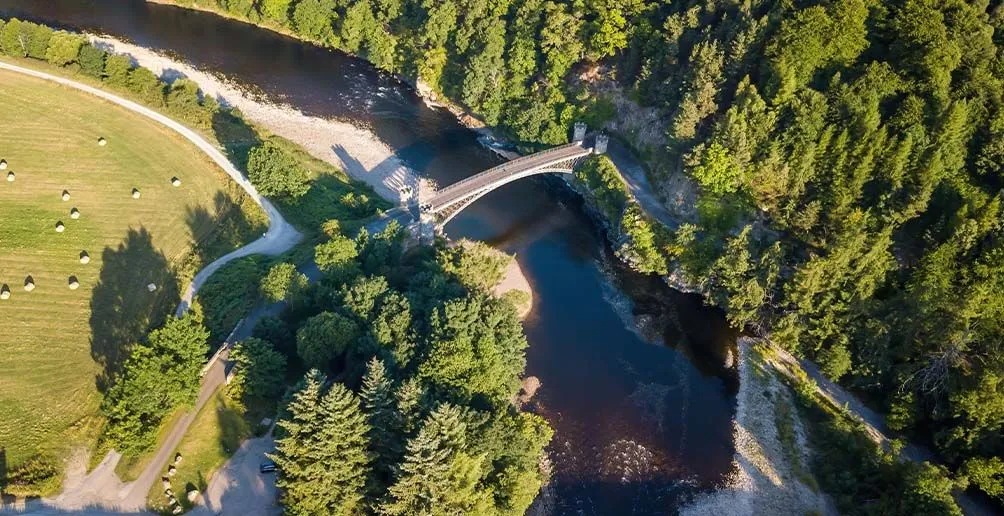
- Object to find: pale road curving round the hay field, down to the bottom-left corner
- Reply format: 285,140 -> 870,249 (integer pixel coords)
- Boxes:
0,61 -> 302,514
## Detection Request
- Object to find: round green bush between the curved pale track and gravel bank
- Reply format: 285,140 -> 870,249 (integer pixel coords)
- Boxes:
247,142 -> 310,199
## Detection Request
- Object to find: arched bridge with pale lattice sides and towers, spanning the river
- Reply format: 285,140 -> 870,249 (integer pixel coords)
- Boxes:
419,123 -> 607,228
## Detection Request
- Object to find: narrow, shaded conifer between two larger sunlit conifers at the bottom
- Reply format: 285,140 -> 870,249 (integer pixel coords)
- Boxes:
359,356 -> 404,479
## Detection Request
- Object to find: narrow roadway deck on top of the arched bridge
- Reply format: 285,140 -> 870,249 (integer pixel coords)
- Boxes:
427,143 -> 590,212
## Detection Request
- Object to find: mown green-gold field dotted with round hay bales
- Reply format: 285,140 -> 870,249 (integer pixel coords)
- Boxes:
0,67 -> 266,469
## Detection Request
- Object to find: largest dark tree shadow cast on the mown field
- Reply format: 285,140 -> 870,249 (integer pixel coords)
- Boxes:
90,224 -> 180,392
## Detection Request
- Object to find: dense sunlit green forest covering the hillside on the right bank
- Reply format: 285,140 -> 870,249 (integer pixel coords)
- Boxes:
182,0 -> 1004,501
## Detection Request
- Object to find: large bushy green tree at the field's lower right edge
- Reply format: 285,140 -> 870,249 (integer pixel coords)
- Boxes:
101,317 -> 209,455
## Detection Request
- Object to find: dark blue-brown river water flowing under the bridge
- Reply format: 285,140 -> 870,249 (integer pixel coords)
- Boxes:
0,0 -> 737,515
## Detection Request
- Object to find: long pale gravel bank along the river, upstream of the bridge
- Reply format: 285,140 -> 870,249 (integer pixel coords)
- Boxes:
91,36 -> 418,204
